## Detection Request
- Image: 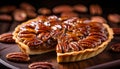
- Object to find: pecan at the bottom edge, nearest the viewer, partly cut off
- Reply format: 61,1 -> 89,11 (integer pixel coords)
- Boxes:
28,62 -> 54,69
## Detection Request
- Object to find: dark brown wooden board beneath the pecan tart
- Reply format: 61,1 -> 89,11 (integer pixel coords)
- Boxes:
0,36 -> 120,69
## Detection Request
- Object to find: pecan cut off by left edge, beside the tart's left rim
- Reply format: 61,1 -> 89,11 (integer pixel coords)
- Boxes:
0,33 -> 15,43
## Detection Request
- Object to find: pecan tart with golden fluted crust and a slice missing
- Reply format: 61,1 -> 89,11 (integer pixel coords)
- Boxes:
13,16 -> 113,62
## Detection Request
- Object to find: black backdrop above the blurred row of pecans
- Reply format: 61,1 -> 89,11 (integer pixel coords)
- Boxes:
0,0 -> 120,13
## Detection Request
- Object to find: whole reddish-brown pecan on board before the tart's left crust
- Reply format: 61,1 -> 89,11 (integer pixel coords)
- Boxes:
6,52 -> 30,62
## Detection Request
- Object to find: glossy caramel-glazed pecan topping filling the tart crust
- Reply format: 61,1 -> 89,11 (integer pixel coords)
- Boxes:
17,16 -> 108,53
